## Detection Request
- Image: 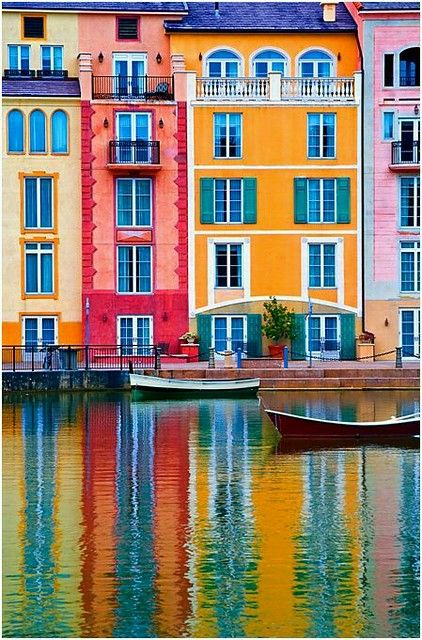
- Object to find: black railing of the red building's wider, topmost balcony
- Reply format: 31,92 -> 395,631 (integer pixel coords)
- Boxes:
92,76 -> 174,100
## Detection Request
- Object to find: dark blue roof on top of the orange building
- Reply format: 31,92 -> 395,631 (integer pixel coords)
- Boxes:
165,2 -> 356,32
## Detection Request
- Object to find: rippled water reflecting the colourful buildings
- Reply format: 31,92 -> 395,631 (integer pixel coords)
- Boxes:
3,392 -> 419,637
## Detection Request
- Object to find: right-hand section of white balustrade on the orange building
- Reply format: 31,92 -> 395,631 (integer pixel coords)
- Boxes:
281,78 -> 355,102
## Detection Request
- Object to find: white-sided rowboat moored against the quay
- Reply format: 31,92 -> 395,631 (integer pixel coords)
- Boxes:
130,373 -> 259,398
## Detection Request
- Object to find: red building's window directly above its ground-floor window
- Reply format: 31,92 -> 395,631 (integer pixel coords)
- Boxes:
117,245 -> 152,293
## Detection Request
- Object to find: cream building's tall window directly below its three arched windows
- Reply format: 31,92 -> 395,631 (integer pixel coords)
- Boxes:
24,178 -> 53,229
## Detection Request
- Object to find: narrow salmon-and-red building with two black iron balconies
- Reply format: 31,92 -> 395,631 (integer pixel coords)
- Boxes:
78,2 -> 188,354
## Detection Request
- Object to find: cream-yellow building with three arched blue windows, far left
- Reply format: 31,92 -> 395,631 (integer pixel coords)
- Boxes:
3,7 -> 82,346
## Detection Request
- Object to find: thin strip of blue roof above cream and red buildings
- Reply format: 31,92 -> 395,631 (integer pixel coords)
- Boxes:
2,0 -> 186,13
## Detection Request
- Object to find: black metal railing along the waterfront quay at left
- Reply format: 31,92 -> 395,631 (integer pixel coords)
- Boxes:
2,344 -> 161,371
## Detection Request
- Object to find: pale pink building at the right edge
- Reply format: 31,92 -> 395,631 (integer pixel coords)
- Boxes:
349,2 -> 420,359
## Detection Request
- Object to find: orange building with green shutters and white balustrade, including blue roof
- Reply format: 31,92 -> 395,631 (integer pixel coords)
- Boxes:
166,3 -> 361,359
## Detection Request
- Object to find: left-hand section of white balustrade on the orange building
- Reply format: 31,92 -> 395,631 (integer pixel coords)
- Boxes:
196,78 -> 270,100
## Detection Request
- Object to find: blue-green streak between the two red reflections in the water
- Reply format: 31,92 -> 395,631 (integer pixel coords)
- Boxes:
113,397 -> 156,638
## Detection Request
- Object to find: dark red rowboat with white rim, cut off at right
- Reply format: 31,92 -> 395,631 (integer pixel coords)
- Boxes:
264,407 -> 420,439
